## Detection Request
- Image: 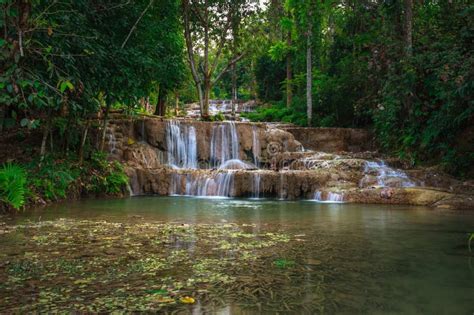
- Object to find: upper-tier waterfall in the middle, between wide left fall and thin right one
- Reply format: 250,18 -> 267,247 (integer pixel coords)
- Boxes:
210,121 -> 240,168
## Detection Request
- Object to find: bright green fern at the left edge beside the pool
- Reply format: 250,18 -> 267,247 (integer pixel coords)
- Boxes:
0,163 -> 27,210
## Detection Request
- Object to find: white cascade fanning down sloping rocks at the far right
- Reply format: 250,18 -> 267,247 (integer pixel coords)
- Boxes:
359,161 -> 416,187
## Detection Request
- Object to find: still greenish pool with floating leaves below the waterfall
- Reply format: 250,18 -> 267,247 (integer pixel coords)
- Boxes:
0,197 -> 474,314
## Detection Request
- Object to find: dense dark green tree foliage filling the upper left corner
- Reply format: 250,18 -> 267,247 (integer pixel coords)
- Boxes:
0,0 -> 185,146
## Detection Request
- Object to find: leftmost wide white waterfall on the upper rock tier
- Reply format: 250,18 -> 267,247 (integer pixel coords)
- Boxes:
166,120 -> 198,169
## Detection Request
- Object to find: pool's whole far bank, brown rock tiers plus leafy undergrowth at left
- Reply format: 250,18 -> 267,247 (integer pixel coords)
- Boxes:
0,114 -> 474,214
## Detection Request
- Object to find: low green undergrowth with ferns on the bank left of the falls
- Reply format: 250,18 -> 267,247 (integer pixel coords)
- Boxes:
0,152 -> 128,210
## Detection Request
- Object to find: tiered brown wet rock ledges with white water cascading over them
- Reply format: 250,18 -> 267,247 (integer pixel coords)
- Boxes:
105,118 -> 474,210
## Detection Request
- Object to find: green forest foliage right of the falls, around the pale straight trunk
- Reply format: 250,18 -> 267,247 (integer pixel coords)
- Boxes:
248,0 -> 474,177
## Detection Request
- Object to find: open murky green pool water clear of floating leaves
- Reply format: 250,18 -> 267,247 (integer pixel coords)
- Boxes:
4,197 -> 474,314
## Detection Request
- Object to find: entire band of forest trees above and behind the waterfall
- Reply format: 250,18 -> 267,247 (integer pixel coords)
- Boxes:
0,0 -> 474,176
